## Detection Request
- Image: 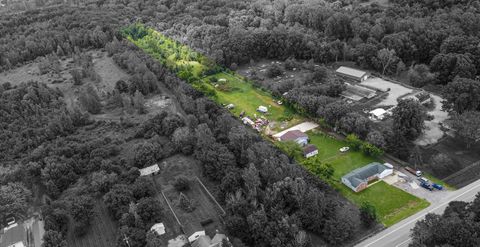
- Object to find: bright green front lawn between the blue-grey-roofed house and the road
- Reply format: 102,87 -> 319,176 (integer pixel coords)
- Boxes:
334,181 -> 430,227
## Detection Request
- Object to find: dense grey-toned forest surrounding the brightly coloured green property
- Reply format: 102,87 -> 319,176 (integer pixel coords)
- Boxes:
0,0 -> 480,246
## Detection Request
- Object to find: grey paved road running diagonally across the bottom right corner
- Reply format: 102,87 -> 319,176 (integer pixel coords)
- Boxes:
356,180 -> 480,247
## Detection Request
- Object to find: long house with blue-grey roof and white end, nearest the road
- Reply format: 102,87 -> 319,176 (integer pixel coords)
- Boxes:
342,162 -> 393,192
